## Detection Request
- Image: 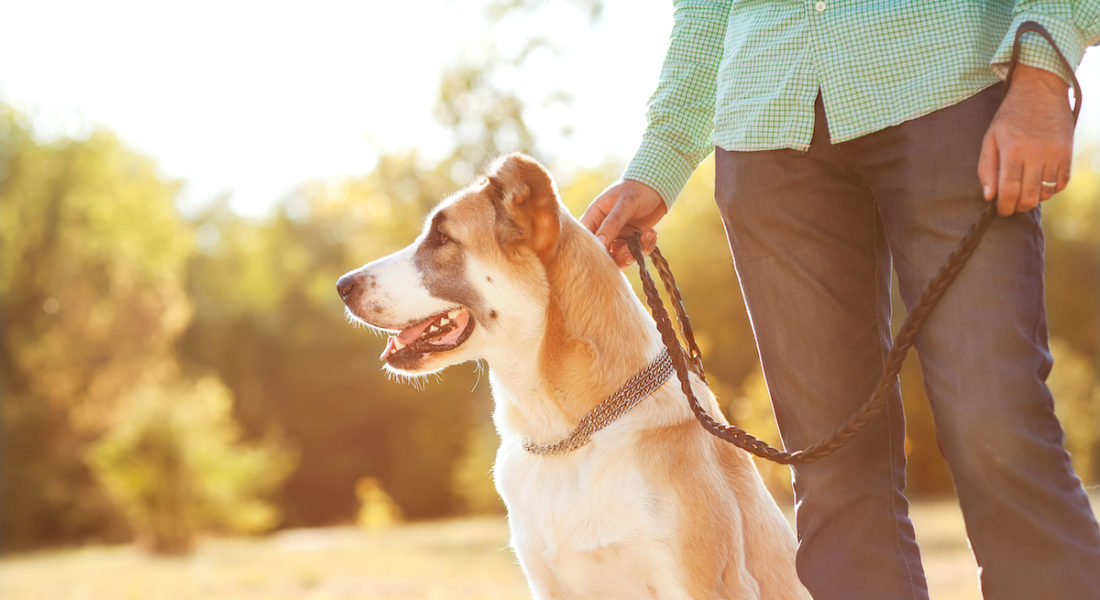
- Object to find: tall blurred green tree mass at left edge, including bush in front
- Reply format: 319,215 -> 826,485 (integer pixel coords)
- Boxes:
0,107 -> 297,550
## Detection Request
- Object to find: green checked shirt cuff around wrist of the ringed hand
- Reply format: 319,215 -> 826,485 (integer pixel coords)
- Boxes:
989,12 -> 1088,86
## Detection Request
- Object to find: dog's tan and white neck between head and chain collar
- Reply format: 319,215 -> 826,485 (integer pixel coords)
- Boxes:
490,220 -> 661,441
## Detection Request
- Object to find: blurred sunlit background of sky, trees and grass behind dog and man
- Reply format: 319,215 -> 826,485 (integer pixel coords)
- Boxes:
0,0 -> 1100,599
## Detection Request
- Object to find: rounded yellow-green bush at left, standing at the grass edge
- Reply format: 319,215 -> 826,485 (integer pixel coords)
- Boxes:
88,378 -> 296,554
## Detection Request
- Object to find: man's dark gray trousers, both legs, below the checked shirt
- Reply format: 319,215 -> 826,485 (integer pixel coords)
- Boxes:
715,85 -> 1100,600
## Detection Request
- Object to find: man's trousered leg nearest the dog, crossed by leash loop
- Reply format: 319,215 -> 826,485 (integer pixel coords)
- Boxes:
715,105 -> 927,600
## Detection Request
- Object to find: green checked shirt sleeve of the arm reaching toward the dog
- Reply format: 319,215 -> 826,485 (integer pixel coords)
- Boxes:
623,0 -> 734,207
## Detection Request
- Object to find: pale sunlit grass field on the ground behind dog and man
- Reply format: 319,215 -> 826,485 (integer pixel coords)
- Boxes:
0,493 -> 1095,600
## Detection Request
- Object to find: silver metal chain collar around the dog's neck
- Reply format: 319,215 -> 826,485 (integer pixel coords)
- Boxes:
524,348 -> 672,456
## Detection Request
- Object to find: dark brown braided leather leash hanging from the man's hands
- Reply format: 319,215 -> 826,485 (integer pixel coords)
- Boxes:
627,21 -> 1081,465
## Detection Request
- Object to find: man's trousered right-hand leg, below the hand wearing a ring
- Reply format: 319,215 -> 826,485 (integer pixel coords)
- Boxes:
837,86 -> 1100,599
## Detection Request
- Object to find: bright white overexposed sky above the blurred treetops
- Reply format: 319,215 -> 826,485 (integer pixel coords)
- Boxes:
0,0 -> 1100,215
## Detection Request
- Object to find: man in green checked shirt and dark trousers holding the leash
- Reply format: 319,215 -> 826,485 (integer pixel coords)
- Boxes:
582,0 -> 1100,600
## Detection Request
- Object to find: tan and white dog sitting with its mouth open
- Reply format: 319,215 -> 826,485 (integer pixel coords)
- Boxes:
337,154 -> 810,600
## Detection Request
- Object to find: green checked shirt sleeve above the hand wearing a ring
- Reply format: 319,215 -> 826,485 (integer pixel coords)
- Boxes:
990,0 -> 1100,84
